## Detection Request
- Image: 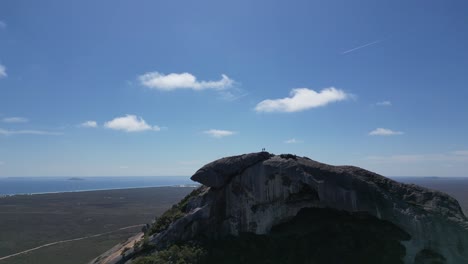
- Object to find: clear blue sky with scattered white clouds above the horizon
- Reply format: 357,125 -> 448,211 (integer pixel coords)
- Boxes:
0,0 -> 468,176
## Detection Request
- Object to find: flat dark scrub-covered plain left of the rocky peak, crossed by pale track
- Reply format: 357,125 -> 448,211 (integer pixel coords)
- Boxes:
0,187 -> 193,264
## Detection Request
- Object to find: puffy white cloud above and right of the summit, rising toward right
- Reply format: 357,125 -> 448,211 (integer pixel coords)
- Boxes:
255,87 -> 351,112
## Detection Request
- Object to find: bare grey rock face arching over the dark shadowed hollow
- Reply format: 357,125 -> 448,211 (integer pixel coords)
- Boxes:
91,152 -> 468,263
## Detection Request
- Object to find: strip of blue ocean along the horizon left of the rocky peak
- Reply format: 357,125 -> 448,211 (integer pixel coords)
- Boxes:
0,176 -> 197,196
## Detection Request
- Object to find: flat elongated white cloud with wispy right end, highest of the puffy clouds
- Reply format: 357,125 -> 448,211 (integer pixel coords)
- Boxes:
138,72 -> 234,91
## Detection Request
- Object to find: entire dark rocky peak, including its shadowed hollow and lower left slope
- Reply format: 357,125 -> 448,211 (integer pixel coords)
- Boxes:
91,152 -> 468,264
